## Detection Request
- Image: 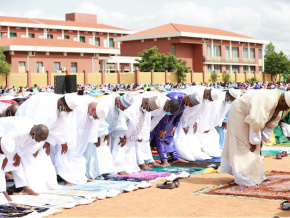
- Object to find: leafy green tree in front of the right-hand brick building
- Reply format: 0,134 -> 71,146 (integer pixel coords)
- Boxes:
136,46 -> 189,83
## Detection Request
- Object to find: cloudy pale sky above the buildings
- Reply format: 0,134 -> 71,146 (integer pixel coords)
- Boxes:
0,0 -> 290,55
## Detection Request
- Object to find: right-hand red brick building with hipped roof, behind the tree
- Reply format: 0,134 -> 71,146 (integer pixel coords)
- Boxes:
114,23 -> 268,73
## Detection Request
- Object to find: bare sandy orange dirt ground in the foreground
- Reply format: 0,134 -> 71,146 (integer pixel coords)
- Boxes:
51,156 -> 290,217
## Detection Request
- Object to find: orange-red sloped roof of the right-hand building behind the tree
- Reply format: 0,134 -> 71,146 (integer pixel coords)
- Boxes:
125,23 -> 254,39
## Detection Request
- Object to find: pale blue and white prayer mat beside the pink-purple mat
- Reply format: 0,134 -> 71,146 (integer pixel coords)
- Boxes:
59,180 -> 138,192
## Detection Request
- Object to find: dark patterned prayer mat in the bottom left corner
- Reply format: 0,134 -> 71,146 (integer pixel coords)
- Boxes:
0,203 -> 49,217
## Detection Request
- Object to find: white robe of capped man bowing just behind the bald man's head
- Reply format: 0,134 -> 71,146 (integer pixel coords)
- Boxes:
16,93 -> 66,192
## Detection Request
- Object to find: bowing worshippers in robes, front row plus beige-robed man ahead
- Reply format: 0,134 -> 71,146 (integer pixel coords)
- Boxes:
0,82 -> 290,204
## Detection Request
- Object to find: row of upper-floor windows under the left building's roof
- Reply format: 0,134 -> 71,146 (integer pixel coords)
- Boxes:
0,33 -> 114,48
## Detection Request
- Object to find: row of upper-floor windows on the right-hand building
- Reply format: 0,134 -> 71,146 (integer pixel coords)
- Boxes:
207,45 -> 263,59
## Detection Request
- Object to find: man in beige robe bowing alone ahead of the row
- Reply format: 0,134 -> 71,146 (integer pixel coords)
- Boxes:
220,90 -> 290,186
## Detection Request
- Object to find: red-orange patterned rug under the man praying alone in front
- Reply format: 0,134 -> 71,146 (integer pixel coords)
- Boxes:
192,171 -> 290,200
